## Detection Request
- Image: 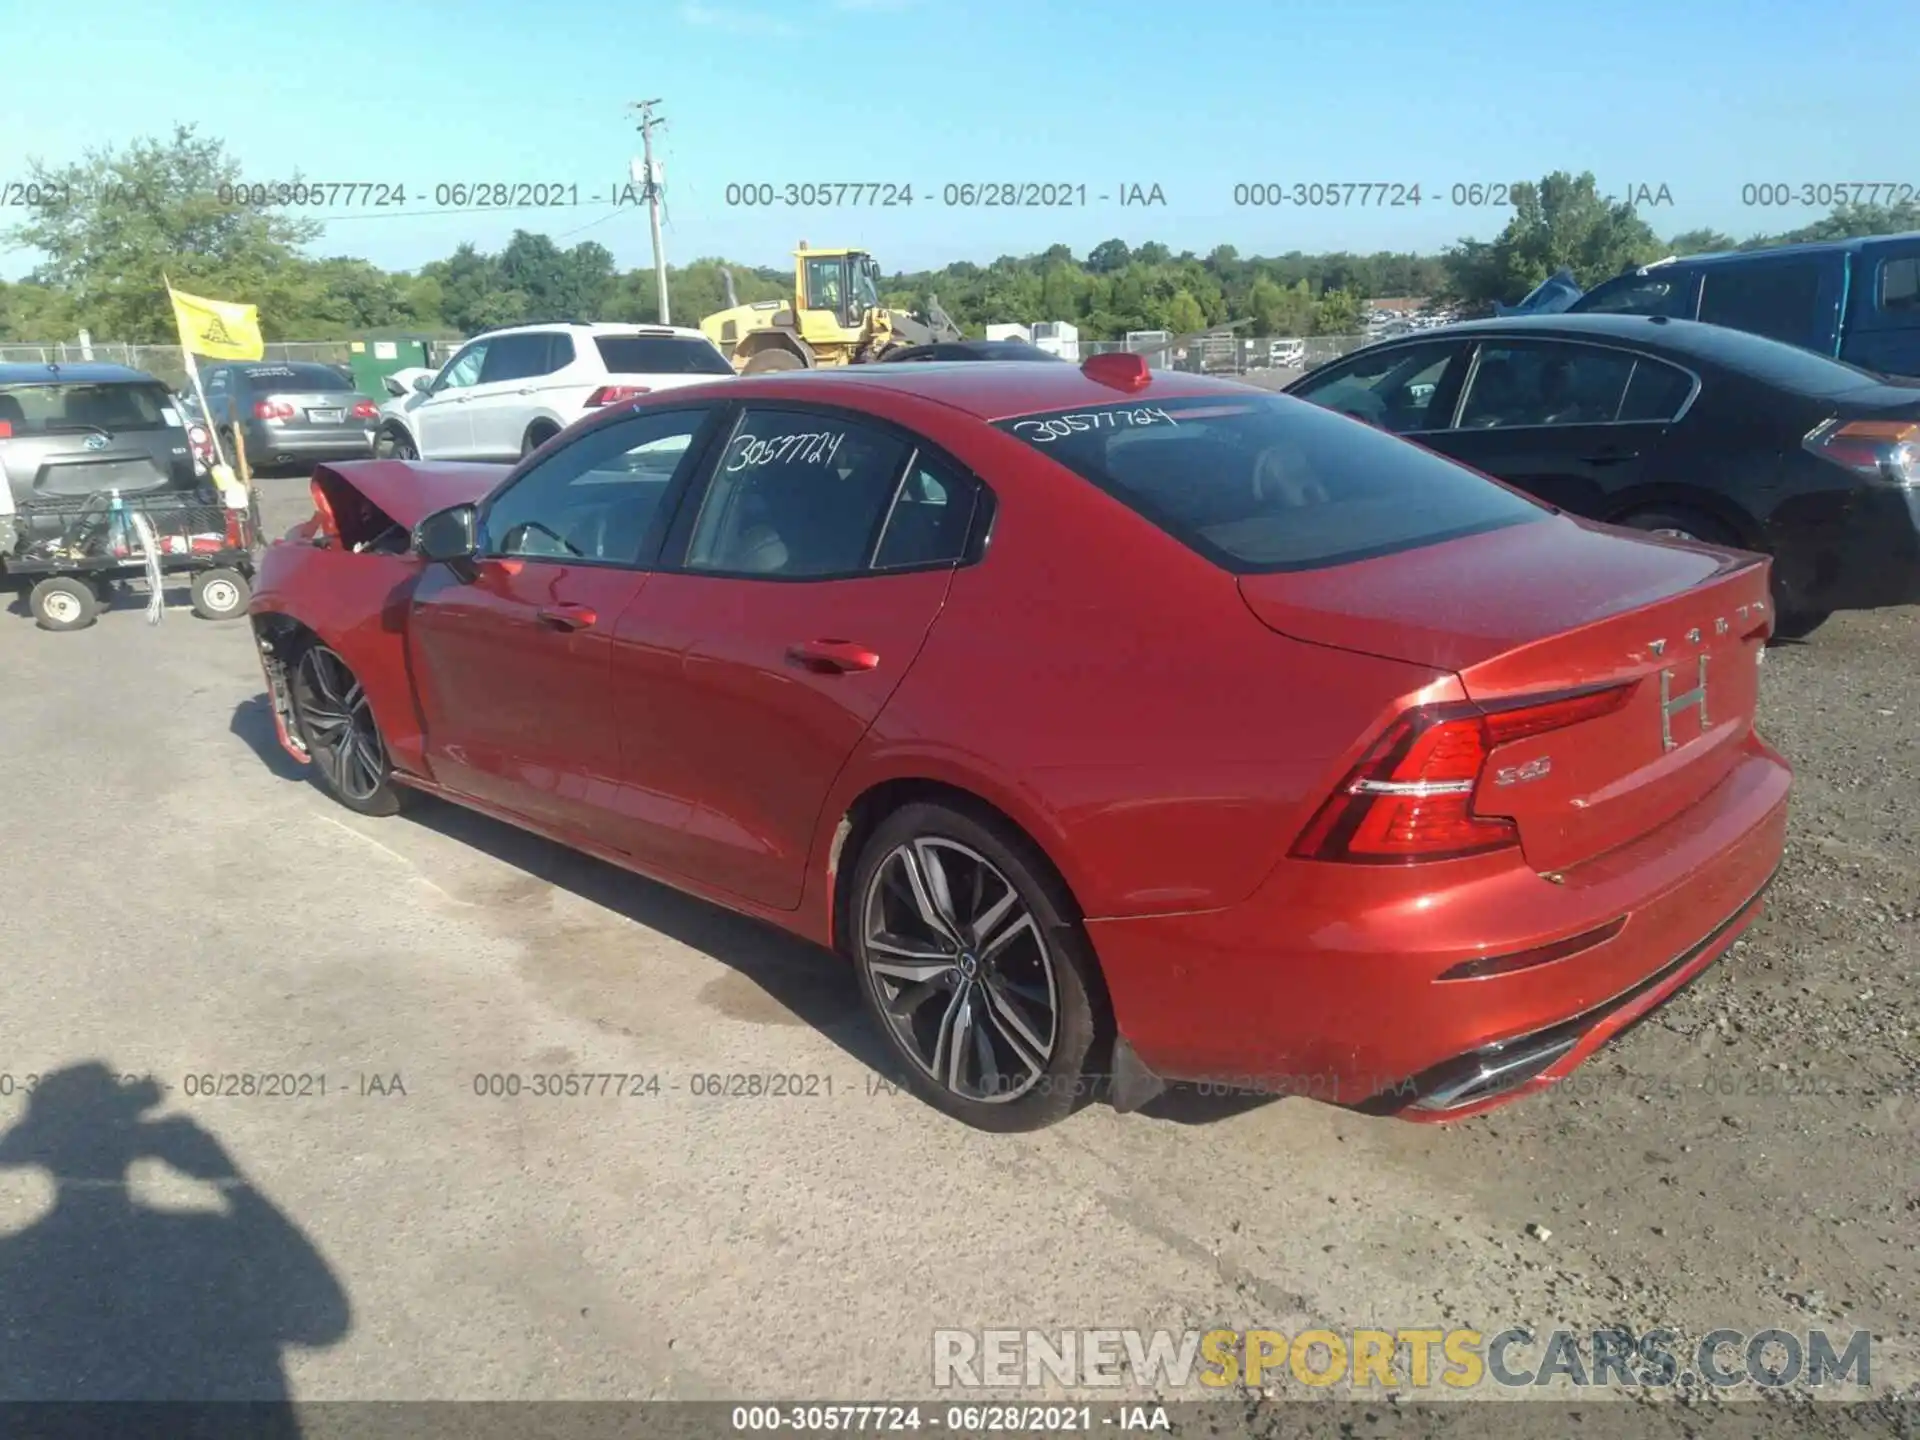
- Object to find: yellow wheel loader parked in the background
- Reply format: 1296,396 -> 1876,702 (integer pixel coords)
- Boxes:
701,240 -> 960,374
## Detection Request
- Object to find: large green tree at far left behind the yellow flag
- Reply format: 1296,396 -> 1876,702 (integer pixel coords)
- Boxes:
6,125 -> 321,344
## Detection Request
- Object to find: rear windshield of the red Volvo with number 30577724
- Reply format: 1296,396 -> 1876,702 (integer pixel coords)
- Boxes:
998,396 -> 1548,574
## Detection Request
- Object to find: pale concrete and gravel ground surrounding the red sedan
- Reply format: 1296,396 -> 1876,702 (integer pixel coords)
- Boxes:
0,482 -> 1920,1400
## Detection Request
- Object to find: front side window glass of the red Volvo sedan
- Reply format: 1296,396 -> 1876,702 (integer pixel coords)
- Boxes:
486,411 -> 707,564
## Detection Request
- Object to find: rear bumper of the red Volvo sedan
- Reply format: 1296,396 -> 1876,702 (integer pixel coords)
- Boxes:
1089,737 -> 1791,1119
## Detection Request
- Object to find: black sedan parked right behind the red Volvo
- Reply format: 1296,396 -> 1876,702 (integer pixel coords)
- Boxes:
1288,315 -> 1920,637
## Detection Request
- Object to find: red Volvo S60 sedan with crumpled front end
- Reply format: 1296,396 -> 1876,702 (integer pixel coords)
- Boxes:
253,353 -> 1789,1129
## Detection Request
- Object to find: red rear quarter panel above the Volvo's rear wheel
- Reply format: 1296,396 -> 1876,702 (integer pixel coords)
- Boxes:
816,410 -> 1459,918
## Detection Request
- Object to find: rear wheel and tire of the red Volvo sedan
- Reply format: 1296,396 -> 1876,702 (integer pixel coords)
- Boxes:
847,803 -> 1106,1133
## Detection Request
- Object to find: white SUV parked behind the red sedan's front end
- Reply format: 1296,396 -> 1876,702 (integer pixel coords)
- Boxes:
374,321 -> 733,461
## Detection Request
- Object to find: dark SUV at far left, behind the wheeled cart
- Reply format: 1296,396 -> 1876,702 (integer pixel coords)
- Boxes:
0,363 -> 200,513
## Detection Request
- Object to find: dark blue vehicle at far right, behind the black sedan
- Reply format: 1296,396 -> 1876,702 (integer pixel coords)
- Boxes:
1567,232 -> 1920,374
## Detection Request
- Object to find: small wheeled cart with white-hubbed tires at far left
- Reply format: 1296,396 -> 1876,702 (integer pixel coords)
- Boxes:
0,482 -> 259,630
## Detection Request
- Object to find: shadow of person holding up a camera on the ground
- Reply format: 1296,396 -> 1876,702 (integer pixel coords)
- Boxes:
0,1062 -> 349,1436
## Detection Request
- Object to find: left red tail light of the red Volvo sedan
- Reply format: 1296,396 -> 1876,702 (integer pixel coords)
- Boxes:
1294,684 -> 1634,864
